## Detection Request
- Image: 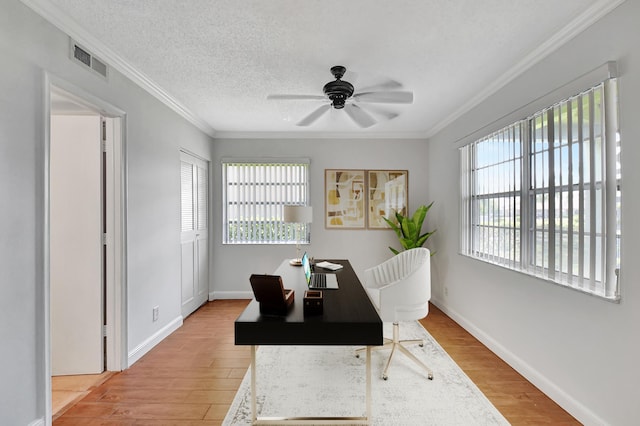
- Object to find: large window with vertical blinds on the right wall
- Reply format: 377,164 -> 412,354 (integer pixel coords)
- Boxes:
460,79 -> 621,300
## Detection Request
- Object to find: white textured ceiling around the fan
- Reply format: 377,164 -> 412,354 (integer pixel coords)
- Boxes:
23,0 -> 620,137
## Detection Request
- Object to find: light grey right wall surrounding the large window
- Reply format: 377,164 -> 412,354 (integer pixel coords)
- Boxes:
428,1 -> 640,425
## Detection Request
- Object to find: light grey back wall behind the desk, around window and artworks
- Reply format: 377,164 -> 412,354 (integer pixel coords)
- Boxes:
211,139 -> 432,298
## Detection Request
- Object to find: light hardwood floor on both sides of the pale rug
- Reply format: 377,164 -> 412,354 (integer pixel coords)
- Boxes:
54,300 -> 579,426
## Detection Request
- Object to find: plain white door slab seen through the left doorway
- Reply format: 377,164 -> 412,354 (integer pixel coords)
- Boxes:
50,115 -> 104,375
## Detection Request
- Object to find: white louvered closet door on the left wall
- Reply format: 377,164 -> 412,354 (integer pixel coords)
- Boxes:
180,152 -> 209,317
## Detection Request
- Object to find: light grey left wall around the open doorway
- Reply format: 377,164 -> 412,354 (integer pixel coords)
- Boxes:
0,0 -> 211,425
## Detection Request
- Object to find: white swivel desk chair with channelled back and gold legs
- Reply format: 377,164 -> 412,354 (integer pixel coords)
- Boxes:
356,247 -> 433,380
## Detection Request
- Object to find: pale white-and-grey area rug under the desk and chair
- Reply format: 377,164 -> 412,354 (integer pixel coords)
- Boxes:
223,322 -> 509,426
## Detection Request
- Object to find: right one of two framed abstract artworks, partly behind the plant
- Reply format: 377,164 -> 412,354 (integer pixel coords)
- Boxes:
367,170 -> 409,229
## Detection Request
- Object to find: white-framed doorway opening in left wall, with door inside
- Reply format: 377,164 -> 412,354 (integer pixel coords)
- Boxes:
45,76 -> 127,419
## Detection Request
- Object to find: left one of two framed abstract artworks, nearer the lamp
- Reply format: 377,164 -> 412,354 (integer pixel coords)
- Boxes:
324,169 -> 367,229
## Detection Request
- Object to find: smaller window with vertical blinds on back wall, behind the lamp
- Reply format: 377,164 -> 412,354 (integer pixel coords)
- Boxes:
222,159 -> 310,244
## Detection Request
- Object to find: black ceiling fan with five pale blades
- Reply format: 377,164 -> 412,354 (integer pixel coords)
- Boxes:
267,65 -> 413,127
